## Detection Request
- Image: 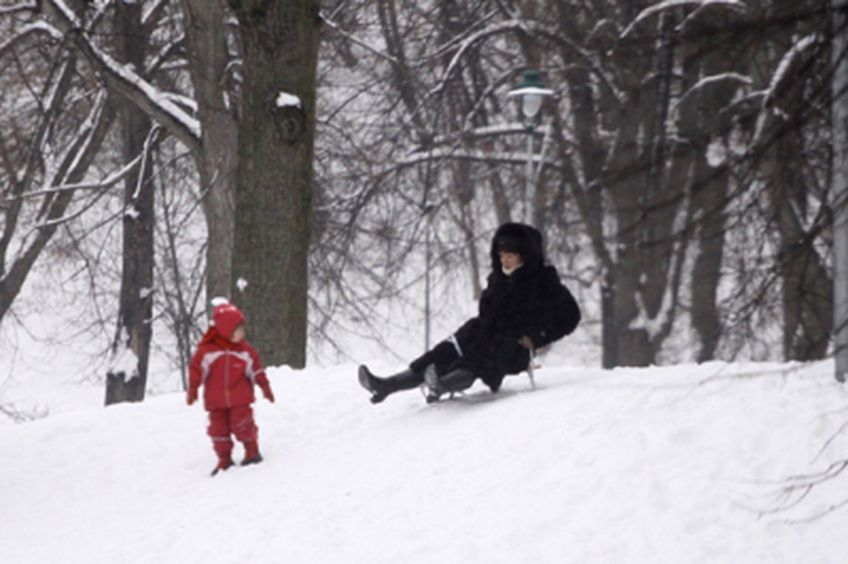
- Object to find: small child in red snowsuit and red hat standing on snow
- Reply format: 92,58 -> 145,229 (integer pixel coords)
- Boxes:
186,303 -> 274,476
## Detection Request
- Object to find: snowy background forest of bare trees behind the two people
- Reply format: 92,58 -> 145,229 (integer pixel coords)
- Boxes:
0,0 -> 836,401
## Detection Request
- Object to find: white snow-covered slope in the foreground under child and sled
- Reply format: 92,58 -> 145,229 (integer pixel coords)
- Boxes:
0,363 -> 848,564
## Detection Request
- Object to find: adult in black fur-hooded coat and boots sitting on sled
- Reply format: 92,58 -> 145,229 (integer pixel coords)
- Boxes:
359,223 -> 580,403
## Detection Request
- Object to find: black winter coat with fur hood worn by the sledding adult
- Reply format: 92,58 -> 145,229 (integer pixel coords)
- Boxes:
413,223 -> 580,391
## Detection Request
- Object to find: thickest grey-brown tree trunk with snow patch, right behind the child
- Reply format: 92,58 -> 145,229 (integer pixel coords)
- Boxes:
229,0 -> 320,368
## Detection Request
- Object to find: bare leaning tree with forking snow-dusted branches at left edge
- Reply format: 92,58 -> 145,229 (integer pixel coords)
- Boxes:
0,2 -> 117,326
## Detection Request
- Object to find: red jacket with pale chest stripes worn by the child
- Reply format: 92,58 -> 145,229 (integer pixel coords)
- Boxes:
189,327 -> 270,411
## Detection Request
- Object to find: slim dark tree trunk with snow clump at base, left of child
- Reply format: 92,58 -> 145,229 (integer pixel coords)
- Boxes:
106,2 -> 155,405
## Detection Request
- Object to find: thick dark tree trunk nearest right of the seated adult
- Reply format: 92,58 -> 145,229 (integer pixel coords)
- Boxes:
605,13 -> 673,366
